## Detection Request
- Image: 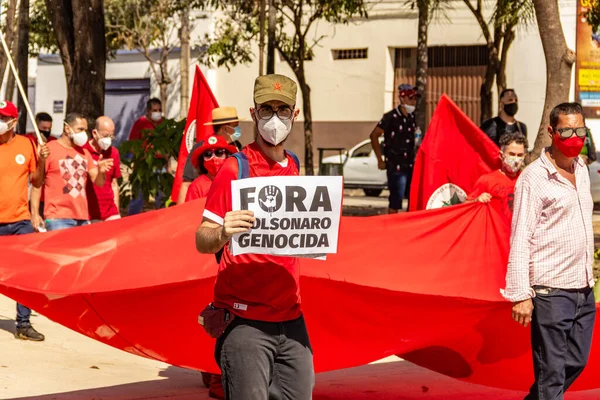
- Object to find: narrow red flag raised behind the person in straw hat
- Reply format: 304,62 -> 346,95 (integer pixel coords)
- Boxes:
171,65 -> 219,202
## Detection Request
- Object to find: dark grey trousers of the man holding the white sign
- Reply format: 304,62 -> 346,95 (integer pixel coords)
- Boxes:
215,317 -> 315,400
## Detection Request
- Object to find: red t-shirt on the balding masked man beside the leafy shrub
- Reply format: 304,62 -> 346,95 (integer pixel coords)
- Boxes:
83,142 -> 121,221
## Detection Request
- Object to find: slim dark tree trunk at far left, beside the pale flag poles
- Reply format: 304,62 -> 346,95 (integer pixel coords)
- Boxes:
16,0 -> 29,133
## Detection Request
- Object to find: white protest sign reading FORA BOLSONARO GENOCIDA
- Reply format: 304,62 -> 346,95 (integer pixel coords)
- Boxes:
231,176 -> 344,257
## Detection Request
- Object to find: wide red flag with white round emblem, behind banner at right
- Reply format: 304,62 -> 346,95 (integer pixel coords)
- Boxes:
410,94 -> 501,211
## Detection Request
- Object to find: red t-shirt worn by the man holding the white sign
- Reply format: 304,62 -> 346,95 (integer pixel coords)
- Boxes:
204,143 -> 301,322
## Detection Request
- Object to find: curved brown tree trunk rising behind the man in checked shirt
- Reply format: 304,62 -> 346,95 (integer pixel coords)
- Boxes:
531,0 -> 575,161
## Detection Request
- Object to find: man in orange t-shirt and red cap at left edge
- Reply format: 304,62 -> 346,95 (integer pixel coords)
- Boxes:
0,101 -> 50,342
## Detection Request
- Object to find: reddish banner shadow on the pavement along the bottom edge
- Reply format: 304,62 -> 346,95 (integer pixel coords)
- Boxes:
4,361 -> 600,400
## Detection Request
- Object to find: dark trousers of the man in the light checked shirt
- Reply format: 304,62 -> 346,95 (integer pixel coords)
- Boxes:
525,288 -> 596,400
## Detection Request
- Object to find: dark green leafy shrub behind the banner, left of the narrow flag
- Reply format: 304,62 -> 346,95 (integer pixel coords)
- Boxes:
119,119 -> 186,207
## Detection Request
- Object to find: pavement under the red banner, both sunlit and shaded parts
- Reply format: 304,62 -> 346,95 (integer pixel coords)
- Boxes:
0,295 -> 600,400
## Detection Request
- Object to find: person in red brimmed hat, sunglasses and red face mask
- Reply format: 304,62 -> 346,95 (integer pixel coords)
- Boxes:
185,136 -> 237,202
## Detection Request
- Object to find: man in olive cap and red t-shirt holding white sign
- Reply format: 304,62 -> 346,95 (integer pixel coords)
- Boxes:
196,74 -> 314,400
